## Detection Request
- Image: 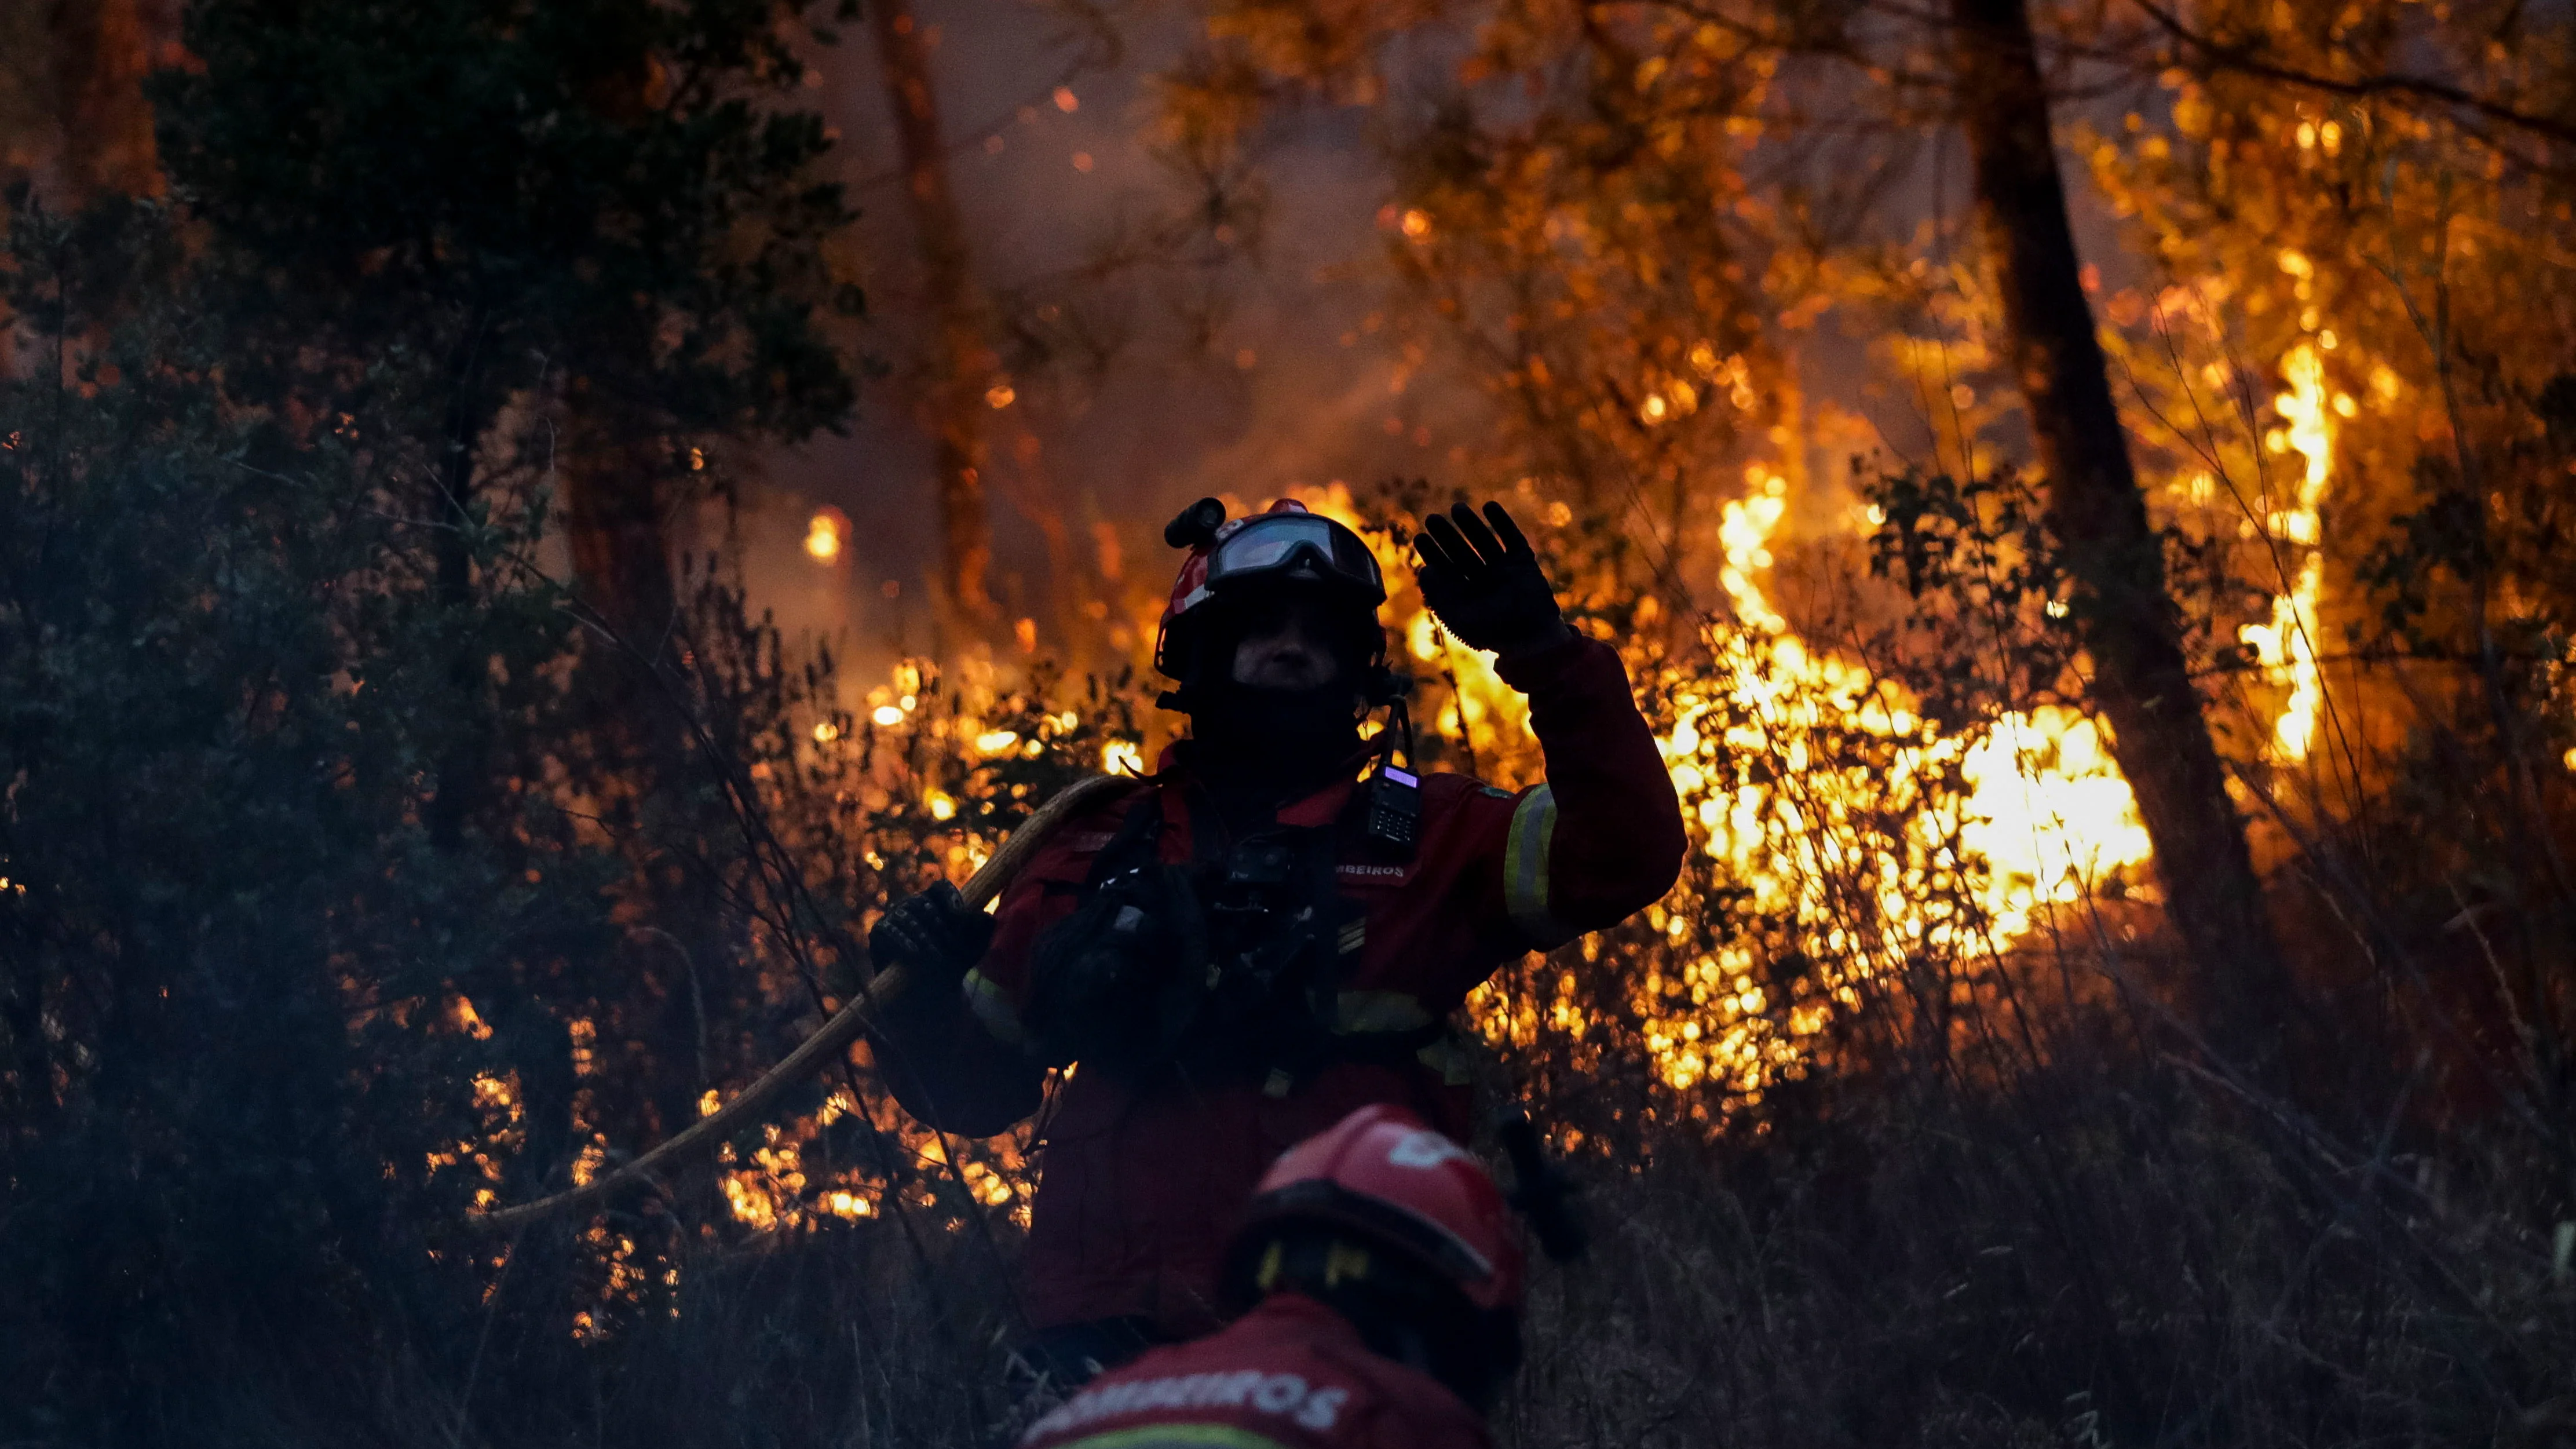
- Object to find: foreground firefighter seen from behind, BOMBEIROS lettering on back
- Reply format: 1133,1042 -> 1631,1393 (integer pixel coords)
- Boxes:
1020,1106 -> 1522,1449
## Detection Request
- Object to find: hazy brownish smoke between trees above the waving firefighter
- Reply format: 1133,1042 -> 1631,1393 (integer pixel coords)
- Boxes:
744,2 -> 1474,649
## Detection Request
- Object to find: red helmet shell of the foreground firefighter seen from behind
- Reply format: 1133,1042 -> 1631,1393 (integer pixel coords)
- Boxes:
1244,1104 -> 1528,1312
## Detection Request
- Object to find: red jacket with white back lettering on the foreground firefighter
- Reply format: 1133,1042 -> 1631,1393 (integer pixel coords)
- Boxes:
1020,1294 -> 1492,1449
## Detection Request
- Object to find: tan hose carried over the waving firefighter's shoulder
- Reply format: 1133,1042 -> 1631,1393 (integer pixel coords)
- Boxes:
466,776 -> 1136,1232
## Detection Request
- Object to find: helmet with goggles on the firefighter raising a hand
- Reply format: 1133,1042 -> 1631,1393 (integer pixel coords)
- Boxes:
1154,498 -> 1386,678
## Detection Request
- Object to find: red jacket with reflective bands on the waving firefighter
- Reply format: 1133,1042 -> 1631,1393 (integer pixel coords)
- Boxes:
881,640 -> 1685,1338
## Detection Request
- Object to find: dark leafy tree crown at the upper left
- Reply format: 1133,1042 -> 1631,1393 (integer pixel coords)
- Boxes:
155,0 -> 858,441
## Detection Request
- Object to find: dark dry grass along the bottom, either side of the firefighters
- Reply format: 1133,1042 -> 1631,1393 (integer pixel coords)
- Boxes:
407,948 -> 2576,1449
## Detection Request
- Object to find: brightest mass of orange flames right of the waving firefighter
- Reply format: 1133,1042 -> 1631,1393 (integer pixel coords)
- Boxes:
1442,469 -> 2149,1101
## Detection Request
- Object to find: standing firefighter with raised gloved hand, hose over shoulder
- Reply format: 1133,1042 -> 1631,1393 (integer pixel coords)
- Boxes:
868,500 -> 1685,1382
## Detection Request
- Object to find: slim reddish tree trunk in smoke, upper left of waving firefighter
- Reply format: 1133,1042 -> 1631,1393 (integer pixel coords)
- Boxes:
868,0 -> 995,634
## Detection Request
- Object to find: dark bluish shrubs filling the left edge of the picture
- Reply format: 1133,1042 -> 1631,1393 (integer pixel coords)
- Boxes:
0,189 -> 611,1441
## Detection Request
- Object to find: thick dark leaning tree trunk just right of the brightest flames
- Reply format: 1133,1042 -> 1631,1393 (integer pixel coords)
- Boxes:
1950,0 -> 2285,1052
